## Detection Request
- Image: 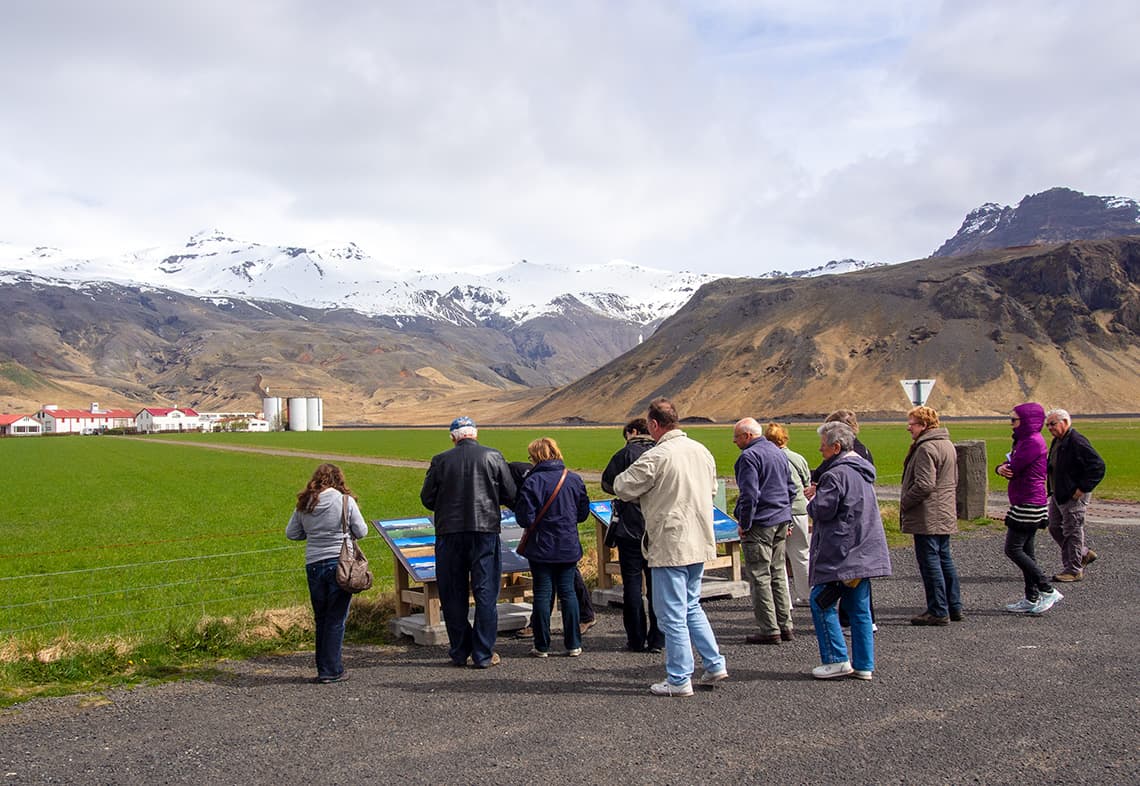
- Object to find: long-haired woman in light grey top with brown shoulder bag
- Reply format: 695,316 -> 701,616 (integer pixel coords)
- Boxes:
285,464 -> 368,683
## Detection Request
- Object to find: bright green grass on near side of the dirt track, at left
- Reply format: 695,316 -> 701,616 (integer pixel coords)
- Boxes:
0,437 -> 423,638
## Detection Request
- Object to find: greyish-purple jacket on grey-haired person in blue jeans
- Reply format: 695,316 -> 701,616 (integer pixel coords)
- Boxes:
807,452 -> 890,586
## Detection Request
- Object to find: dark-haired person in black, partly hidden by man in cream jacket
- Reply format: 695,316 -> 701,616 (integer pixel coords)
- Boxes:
602,418 -> 665,653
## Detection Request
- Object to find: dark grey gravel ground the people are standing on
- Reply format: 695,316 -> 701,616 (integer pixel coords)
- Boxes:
0,517 -> 1140,784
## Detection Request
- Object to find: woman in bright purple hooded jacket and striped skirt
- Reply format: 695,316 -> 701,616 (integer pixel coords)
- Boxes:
994,402 -> 1062,614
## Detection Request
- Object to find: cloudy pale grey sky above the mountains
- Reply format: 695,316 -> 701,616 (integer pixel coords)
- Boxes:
0,0 -> 1140,275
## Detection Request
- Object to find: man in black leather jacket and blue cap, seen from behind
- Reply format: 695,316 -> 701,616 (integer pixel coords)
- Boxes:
420,416 -> 516,668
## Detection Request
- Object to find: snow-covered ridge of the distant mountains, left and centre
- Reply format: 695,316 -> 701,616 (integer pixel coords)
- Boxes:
0,229 -> 720,325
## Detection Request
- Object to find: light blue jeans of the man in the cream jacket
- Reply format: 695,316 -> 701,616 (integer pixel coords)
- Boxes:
652,562 -> 725,686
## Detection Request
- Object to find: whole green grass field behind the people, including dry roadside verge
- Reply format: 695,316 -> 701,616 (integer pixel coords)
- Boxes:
0,421 -> 1140,704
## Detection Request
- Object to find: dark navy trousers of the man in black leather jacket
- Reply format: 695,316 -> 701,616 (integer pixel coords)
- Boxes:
435,533 -> 503,666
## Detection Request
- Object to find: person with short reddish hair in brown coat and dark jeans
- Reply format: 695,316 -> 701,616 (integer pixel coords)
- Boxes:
898,406 -> 962,625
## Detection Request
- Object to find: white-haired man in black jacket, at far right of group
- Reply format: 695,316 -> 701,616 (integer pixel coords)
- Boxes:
1045,410 -> 1105,582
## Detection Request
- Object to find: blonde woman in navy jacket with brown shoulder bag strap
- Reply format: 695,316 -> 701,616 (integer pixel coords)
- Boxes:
514,437 -> 589,658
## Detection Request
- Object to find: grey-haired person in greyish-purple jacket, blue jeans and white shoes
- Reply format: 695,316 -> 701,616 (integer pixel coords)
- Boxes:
807,422 -> 890,680
